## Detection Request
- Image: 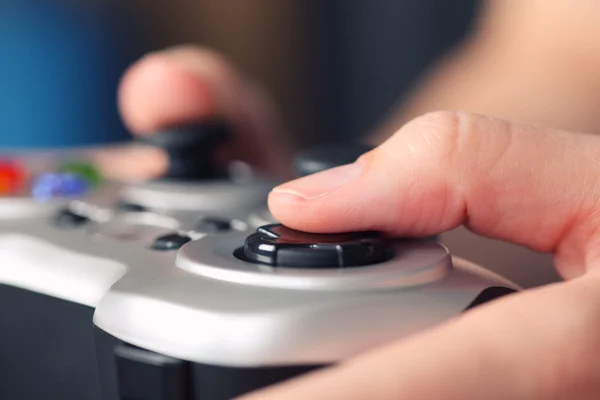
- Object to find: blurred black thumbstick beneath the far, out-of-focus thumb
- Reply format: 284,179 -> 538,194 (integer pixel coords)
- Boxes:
138,119 -> 230,180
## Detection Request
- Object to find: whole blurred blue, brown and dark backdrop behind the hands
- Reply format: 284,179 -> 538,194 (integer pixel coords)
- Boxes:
0,0 -> 554,286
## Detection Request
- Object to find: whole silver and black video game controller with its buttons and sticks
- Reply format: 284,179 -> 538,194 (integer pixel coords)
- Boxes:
0,121 -> 519,400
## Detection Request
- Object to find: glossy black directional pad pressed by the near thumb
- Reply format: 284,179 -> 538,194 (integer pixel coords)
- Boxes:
243,224 -> 388,268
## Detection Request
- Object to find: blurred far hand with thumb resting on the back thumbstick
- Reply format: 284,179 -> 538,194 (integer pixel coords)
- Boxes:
92,46 -> 291,181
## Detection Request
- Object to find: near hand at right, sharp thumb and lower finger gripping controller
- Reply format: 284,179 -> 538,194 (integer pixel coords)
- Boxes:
240,112 -> 600,400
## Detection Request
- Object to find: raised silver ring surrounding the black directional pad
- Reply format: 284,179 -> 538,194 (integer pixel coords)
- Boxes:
176,234 -> 452,291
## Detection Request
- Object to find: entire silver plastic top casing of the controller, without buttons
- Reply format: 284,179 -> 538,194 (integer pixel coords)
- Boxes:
0,150 -> 517,366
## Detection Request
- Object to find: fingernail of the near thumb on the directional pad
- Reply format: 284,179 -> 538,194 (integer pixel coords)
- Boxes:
272,163 -> 363,200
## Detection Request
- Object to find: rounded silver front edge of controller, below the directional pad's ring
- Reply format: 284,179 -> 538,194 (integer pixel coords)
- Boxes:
94,248 -> 506,367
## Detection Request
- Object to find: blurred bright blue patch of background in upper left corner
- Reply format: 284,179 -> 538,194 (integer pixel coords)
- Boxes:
0,0 -> 134,148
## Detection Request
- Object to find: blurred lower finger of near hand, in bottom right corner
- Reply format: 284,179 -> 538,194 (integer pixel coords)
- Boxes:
245,276 -> 600,400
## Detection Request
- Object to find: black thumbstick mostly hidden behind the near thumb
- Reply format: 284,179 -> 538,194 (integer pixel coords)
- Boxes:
293,143 -> 374,177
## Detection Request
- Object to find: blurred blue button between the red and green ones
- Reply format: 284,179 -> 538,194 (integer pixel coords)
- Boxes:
31,173 -> 90,201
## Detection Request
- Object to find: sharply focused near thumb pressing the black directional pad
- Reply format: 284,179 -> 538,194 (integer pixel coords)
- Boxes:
269,112 -> 600,276
